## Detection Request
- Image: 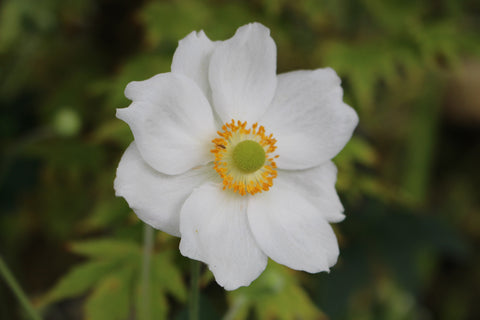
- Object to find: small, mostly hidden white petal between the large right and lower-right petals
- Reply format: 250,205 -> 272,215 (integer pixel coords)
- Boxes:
274,161 -> 345,222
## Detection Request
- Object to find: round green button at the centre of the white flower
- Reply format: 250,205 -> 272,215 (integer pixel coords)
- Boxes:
233,140 -> 265,173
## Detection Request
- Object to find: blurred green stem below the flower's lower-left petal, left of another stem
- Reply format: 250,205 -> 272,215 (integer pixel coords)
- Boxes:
140,224 -> 155,319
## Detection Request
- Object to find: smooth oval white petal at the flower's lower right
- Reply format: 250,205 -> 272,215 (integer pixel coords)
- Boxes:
248,183 -> 339,273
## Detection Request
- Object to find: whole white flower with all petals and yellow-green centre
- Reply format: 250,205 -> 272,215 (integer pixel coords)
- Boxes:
115,23 -> 358,290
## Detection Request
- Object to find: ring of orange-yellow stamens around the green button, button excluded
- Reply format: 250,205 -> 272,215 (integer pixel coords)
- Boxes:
211,119 -> 278,196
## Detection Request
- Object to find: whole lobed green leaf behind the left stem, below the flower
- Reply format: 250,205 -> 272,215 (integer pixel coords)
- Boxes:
42,235 -> 187,320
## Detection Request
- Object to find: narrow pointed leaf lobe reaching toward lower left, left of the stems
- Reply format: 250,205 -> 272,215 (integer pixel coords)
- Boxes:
41,261 -> 116,305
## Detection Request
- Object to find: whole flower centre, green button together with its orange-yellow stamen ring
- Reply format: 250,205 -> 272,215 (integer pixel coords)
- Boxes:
211,120 -> 278,196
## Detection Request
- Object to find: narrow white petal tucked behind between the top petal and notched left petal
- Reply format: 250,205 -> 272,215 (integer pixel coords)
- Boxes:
172,30 -> 215,97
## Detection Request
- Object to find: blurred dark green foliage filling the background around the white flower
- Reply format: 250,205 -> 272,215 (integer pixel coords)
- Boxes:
0,0 -> 480,320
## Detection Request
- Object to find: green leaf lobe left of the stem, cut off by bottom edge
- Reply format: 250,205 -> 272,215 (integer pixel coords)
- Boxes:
85,268 -> 134,320
